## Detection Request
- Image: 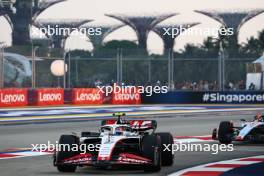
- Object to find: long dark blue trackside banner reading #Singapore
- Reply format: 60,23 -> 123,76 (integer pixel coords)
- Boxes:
142,91 -> 264,104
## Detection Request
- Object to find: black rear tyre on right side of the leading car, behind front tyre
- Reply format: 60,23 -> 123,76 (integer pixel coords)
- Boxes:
157,133 -> 174,166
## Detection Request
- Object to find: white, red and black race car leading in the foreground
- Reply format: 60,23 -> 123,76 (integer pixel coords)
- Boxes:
54,113 -> 174,172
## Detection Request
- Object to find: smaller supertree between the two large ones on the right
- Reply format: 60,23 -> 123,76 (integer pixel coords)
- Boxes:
153,23 -> 200,53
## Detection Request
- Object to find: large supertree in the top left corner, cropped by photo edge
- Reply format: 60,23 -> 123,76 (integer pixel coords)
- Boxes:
0,0 -> 66,45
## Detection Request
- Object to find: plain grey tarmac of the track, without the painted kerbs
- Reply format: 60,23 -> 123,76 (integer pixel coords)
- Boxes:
0,106 -> 264,176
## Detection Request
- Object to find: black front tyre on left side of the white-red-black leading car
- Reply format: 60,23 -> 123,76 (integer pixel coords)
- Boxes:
56,135 -> 79,172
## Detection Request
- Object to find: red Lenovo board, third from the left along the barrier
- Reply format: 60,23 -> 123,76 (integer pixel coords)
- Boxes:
71,88 -> 104,105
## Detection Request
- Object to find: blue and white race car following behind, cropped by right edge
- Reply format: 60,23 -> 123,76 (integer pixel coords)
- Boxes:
212,114 -> 264,144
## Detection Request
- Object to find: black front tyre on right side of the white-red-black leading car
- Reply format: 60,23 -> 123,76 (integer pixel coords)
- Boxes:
142,134 -> 161,172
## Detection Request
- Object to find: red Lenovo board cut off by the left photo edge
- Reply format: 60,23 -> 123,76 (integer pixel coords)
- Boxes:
0,89 -> 28,107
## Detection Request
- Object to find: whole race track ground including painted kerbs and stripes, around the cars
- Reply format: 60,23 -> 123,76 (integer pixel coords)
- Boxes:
0,105 -> 264,176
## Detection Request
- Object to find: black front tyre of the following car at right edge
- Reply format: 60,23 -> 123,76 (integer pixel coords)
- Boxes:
218,121 -> 233,144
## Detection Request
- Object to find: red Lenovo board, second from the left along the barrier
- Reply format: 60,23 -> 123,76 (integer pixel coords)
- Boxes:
33,88 -> 64,106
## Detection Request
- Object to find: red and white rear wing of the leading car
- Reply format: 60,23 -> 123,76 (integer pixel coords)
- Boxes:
101,119 -> 157,131
